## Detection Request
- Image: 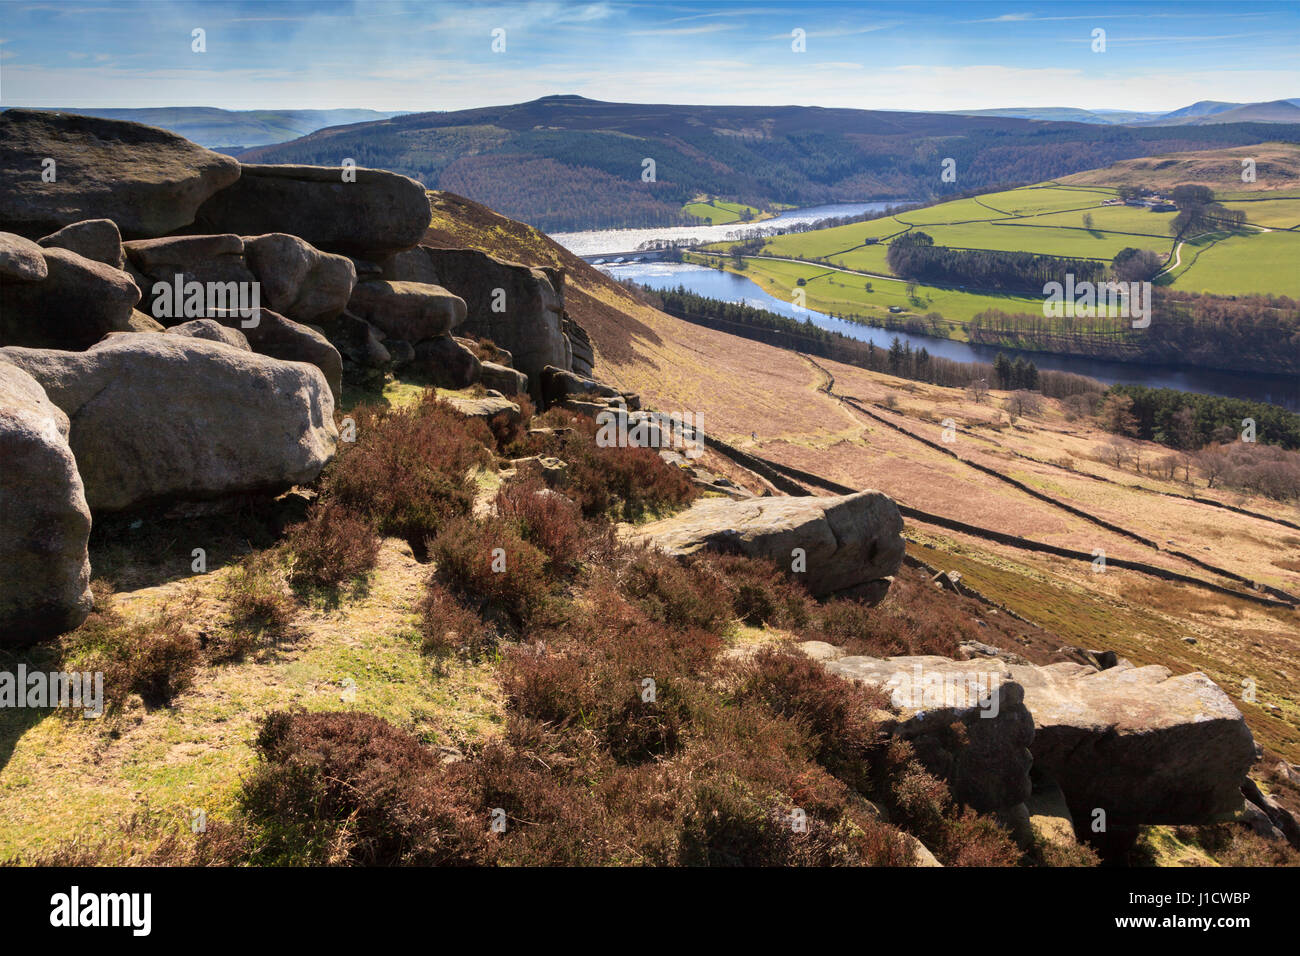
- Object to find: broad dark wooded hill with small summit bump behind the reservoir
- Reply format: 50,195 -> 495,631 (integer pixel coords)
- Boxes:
239,96 -> 1300,232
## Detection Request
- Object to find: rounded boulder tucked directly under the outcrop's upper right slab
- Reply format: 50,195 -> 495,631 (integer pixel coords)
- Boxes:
244,233 -> 356,323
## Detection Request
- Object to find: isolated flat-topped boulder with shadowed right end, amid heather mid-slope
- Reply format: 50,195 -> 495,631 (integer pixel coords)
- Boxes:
625,492 -> 904,596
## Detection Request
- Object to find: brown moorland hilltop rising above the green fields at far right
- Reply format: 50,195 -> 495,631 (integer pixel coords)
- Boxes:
1057,143 -> 1300,193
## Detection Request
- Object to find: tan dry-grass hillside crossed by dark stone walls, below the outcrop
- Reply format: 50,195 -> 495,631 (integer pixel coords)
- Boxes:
426,188 -> 1300,761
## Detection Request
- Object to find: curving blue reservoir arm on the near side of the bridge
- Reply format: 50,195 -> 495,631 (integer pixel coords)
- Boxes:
601,263 -> 1300,411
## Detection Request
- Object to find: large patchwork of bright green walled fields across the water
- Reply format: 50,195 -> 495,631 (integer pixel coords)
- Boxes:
698,144 -> 1300,325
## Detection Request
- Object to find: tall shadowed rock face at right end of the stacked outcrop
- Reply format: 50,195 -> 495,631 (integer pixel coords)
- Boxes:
421,247 -> 572,398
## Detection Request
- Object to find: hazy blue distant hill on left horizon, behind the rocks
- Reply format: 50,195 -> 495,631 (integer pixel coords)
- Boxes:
5,107 -> 399,151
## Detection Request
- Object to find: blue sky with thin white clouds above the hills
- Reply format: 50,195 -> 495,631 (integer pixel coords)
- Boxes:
0,0 -> 1300,111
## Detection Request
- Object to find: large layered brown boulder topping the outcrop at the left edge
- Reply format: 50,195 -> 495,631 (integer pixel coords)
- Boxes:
0,109 -> 241,239
